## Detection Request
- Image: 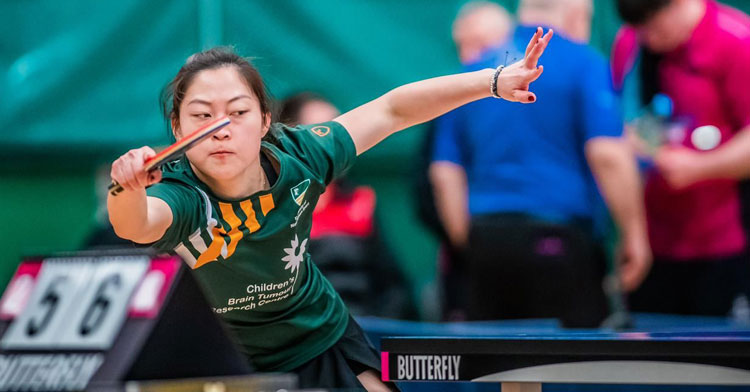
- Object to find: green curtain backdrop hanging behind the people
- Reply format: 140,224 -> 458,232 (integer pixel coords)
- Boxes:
0,0 -> 750,317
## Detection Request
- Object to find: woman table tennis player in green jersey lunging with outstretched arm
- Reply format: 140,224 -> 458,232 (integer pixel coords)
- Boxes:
107,28 -> 552,390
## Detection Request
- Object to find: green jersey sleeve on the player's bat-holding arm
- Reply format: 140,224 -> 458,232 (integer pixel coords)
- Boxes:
146,181 -> 206,251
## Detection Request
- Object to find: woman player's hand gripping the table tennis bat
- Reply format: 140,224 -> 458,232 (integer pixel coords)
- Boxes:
110,146 -> 161,191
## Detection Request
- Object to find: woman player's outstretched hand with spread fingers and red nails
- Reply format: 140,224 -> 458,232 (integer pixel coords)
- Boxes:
497,27 -> 553,103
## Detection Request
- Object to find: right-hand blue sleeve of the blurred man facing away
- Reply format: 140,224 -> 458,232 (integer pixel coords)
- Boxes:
577,54 -> 623,141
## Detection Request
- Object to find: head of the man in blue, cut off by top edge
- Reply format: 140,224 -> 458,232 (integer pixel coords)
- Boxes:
518,0 -> 594,42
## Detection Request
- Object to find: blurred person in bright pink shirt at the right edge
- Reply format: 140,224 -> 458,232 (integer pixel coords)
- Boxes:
612,0 -> 750,315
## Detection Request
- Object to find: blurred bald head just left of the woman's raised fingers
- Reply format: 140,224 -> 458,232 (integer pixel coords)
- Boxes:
453,1 -> 511,64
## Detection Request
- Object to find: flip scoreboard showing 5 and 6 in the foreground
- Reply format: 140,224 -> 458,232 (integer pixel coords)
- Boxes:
0,253 -> 258,391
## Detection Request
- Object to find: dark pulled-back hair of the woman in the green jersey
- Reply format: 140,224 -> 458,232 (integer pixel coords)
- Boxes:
160,47 -> 271,133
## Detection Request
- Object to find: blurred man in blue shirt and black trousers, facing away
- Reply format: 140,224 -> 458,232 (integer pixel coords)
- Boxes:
430,0 -> 651,327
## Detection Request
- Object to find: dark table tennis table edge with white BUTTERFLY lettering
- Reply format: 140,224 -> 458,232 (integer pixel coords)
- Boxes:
381,331 -> 750,392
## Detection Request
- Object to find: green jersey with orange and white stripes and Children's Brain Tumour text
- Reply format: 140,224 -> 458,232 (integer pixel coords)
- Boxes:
147,122 -> 356,371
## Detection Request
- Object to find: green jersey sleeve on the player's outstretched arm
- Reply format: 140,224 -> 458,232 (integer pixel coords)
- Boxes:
277,121 -> 357,184
